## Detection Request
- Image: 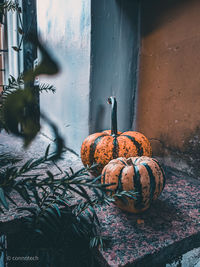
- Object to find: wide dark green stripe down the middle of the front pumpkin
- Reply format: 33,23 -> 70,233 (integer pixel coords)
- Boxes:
133,165 -> 144,209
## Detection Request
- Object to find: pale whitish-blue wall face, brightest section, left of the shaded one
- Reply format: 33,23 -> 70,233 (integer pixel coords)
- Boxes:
37,0 -> 90,153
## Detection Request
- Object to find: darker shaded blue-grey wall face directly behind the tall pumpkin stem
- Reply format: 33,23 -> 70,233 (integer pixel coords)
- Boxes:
90,0 -> 140,133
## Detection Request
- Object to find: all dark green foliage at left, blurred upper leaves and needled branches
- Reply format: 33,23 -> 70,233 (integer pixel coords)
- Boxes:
0,5 -> 138,266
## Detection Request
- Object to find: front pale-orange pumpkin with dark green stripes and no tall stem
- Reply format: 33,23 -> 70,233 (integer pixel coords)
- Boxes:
101,156 -> 165,213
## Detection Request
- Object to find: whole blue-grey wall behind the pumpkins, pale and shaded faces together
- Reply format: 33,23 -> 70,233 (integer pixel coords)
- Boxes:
37,0 -> 140,152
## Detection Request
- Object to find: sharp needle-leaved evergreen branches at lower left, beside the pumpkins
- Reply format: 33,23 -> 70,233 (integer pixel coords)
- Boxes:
0,146 -> 109,248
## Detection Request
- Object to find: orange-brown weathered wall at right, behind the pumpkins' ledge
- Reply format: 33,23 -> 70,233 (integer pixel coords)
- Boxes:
137,0 -> 200,177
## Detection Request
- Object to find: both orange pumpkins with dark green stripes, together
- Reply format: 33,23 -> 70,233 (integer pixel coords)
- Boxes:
81,97 -> 165,213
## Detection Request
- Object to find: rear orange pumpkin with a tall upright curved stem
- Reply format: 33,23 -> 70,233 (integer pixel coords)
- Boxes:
81,97 -> 152,175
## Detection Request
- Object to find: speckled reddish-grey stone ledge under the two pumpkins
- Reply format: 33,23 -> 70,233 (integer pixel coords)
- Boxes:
0,133 -> 200,267
